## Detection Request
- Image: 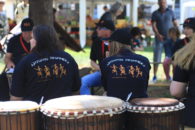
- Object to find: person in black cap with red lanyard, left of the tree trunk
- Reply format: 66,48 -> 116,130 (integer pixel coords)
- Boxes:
4,18 -> 34,69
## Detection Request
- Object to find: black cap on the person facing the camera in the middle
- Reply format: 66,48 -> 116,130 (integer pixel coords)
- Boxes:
96,20 -> 115,31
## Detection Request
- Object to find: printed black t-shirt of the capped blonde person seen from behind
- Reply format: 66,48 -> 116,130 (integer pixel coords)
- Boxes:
100,49 -> 151,100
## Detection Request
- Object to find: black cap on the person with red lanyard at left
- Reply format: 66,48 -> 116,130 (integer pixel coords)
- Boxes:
21,18 -> 34,32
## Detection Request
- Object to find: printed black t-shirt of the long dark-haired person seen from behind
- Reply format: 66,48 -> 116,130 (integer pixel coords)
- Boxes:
11,51 -> 81,102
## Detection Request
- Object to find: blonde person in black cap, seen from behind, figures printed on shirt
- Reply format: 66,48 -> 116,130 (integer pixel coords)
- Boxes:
100,28 -> 151,100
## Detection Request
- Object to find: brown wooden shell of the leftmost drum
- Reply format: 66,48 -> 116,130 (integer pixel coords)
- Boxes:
0,111 -> 40,130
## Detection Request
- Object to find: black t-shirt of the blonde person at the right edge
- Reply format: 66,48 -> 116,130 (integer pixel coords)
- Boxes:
173,66 -> 195,127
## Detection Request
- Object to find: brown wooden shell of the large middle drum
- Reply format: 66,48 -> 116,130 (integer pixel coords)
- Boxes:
43,114 -> 124,130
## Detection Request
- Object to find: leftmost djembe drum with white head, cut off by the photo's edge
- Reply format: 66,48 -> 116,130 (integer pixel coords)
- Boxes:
0,101 -> 39,130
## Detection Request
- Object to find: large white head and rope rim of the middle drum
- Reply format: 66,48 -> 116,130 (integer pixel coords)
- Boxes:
41,95 -> 125,118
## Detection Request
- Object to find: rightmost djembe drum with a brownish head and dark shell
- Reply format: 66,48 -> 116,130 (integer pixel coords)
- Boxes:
127,98 -> 184,130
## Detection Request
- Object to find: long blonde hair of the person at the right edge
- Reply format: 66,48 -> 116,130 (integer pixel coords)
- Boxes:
174,34 -> 195,70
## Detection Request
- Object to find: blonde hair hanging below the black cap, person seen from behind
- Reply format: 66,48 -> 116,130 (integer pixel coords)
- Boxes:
109,41 -> 132,56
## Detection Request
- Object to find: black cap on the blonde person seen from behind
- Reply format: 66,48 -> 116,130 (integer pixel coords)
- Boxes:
110,28 -> 132,45
